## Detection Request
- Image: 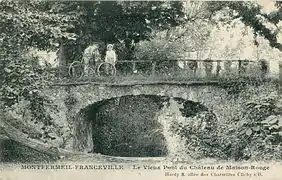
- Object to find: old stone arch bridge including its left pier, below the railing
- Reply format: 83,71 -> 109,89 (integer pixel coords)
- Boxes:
46,81 -> 272,155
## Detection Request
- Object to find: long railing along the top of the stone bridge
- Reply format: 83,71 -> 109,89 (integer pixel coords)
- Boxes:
47,59 -> 274,80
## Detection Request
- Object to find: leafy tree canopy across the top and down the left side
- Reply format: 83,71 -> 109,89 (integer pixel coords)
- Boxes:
0,0 -> 282,158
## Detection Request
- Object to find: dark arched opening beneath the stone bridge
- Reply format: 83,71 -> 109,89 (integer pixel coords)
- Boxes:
74,95 -> 216,157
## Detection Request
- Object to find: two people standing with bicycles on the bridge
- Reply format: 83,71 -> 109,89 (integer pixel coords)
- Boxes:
83,44 -> 117,74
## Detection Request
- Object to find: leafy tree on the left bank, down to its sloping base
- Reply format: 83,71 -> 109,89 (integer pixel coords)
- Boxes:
0,1 -> 77,158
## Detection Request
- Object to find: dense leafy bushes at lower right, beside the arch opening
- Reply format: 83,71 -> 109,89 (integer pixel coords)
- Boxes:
174,85 -> 282,161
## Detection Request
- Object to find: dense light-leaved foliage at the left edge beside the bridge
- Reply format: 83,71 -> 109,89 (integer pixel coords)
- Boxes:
0,1 -> 74,149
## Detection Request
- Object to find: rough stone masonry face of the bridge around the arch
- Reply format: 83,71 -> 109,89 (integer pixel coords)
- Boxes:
46,84 -> 278,153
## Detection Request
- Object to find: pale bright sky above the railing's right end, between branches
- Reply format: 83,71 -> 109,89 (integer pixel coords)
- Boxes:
202,0 -> 282,74
